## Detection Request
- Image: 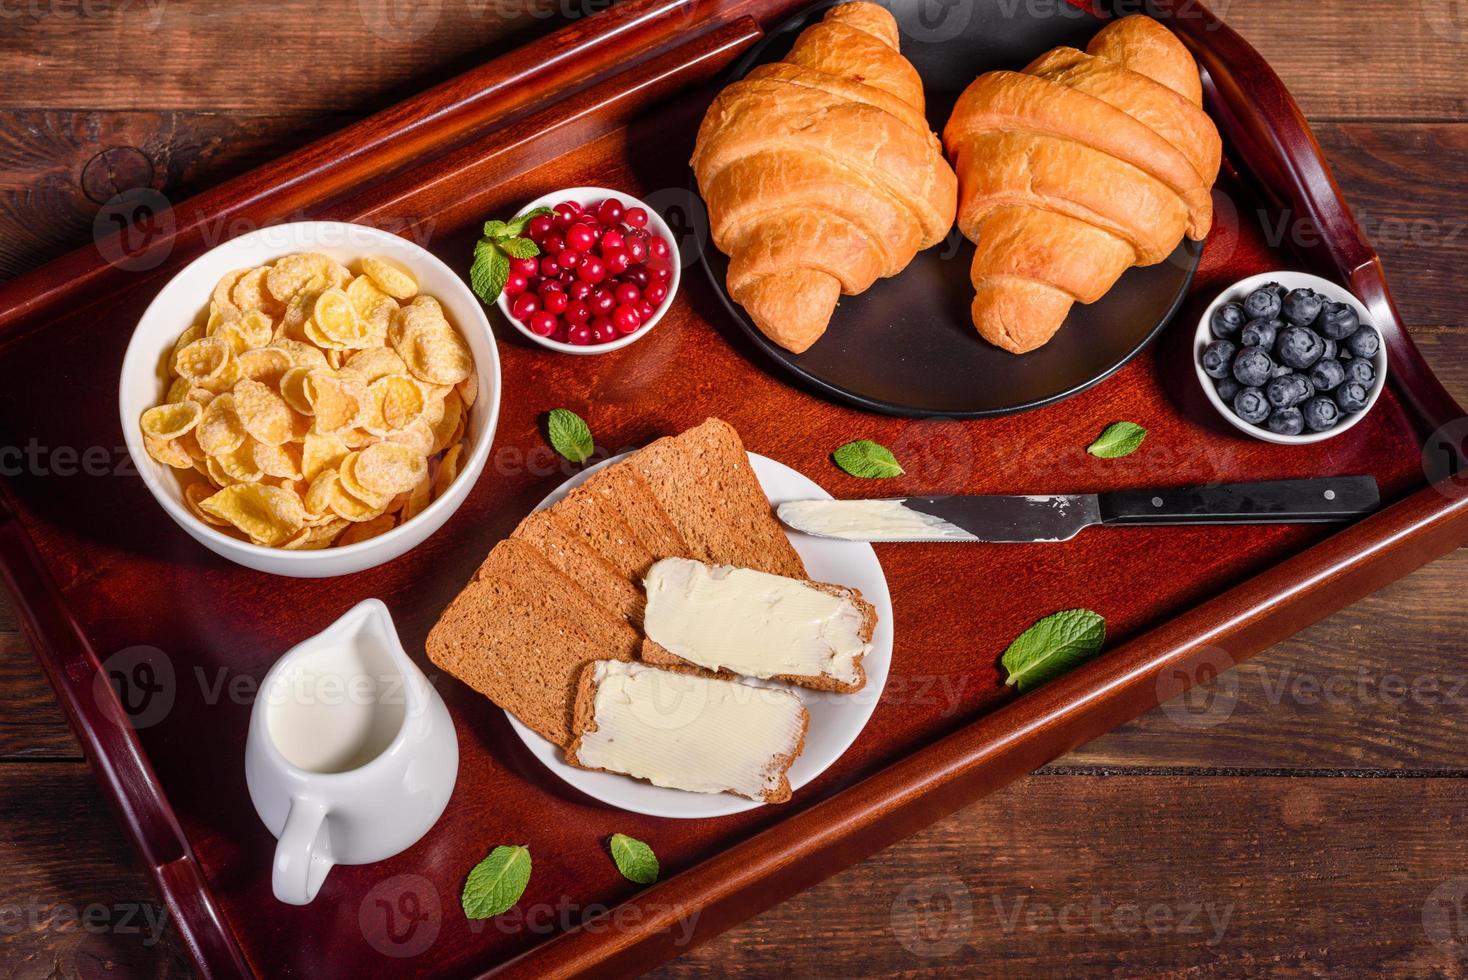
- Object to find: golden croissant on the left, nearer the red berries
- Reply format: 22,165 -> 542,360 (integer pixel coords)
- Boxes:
693,3 -> 957,354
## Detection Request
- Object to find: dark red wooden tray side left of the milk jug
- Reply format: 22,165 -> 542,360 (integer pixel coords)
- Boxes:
0,491 -> 252,977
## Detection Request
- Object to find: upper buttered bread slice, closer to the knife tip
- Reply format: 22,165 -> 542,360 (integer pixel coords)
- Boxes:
642,557 -> 876,692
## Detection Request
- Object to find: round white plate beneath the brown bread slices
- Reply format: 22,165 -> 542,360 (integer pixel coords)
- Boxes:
506,453 -> 893,820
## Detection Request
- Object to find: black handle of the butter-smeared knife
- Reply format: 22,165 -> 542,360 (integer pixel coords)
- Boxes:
1098,477 -> 1381,525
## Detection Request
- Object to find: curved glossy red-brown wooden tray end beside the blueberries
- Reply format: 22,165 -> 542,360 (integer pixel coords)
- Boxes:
1147,0 -> 1464,436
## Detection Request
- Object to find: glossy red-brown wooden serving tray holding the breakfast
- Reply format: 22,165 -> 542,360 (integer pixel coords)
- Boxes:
0,0 -> 1468,977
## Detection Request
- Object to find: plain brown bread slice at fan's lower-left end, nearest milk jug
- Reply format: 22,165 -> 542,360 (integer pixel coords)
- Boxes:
426,538 -> 642,748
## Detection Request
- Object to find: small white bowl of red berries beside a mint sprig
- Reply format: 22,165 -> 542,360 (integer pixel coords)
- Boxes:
496,188 -> 683,354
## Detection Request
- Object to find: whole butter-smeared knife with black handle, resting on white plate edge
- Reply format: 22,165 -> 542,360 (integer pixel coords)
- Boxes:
777,477 -> 1381,544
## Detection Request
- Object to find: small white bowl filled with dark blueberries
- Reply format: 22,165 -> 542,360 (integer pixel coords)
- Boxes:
1193,271 -> 1386,446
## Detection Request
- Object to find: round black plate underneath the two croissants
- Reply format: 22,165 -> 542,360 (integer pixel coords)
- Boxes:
703,0 -> 1202,418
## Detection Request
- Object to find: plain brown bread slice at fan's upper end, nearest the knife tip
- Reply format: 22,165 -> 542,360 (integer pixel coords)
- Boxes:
627,418 -> 806,578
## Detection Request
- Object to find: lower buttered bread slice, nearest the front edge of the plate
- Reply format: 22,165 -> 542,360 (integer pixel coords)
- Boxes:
565,660 -> 810,802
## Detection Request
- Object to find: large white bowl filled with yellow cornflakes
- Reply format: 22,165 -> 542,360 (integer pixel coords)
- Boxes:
117,222 -> 501,578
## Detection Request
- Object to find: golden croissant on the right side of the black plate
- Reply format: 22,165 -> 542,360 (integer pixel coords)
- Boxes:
942,15 -> 1221,354
